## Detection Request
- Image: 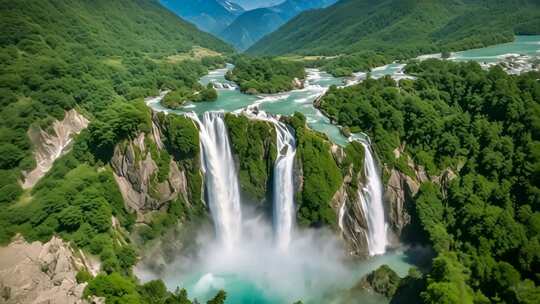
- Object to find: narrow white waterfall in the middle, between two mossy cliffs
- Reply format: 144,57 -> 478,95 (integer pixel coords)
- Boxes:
272,119 -> 296,250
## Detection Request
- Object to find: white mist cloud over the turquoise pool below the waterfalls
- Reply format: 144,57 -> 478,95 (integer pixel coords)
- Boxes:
143,207 -> 357,304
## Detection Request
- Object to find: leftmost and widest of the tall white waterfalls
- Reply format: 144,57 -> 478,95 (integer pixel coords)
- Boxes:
189,112 -> 242,249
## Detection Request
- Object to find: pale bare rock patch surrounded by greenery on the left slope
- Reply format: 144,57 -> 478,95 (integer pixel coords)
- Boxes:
22,109 -> 88,189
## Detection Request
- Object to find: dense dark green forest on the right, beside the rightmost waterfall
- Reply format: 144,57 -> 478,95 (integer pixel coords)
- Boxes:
320,60 -> 540,303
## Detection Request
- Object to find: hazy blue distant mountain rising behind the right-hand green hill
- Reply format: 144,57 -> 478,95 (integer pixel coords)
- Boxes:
219,0 -> 336,50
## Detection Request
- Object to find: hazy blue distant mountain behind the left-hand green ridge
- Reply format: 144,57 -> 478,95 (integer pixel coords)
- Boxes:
160,0 -> 244,34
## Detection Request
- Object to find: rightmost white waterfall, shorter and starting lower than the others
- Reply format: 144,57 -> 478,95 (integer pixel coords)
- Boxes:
358,141 -> 387,256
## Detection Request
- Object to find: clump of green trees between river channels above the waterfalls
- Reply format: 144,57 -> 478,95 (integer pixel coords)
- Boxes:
226,56 -> 305,94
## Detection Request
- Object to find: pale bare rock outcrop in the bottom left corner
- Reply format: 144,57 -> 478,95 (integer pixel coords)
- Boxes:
0,237 -> 86,304
